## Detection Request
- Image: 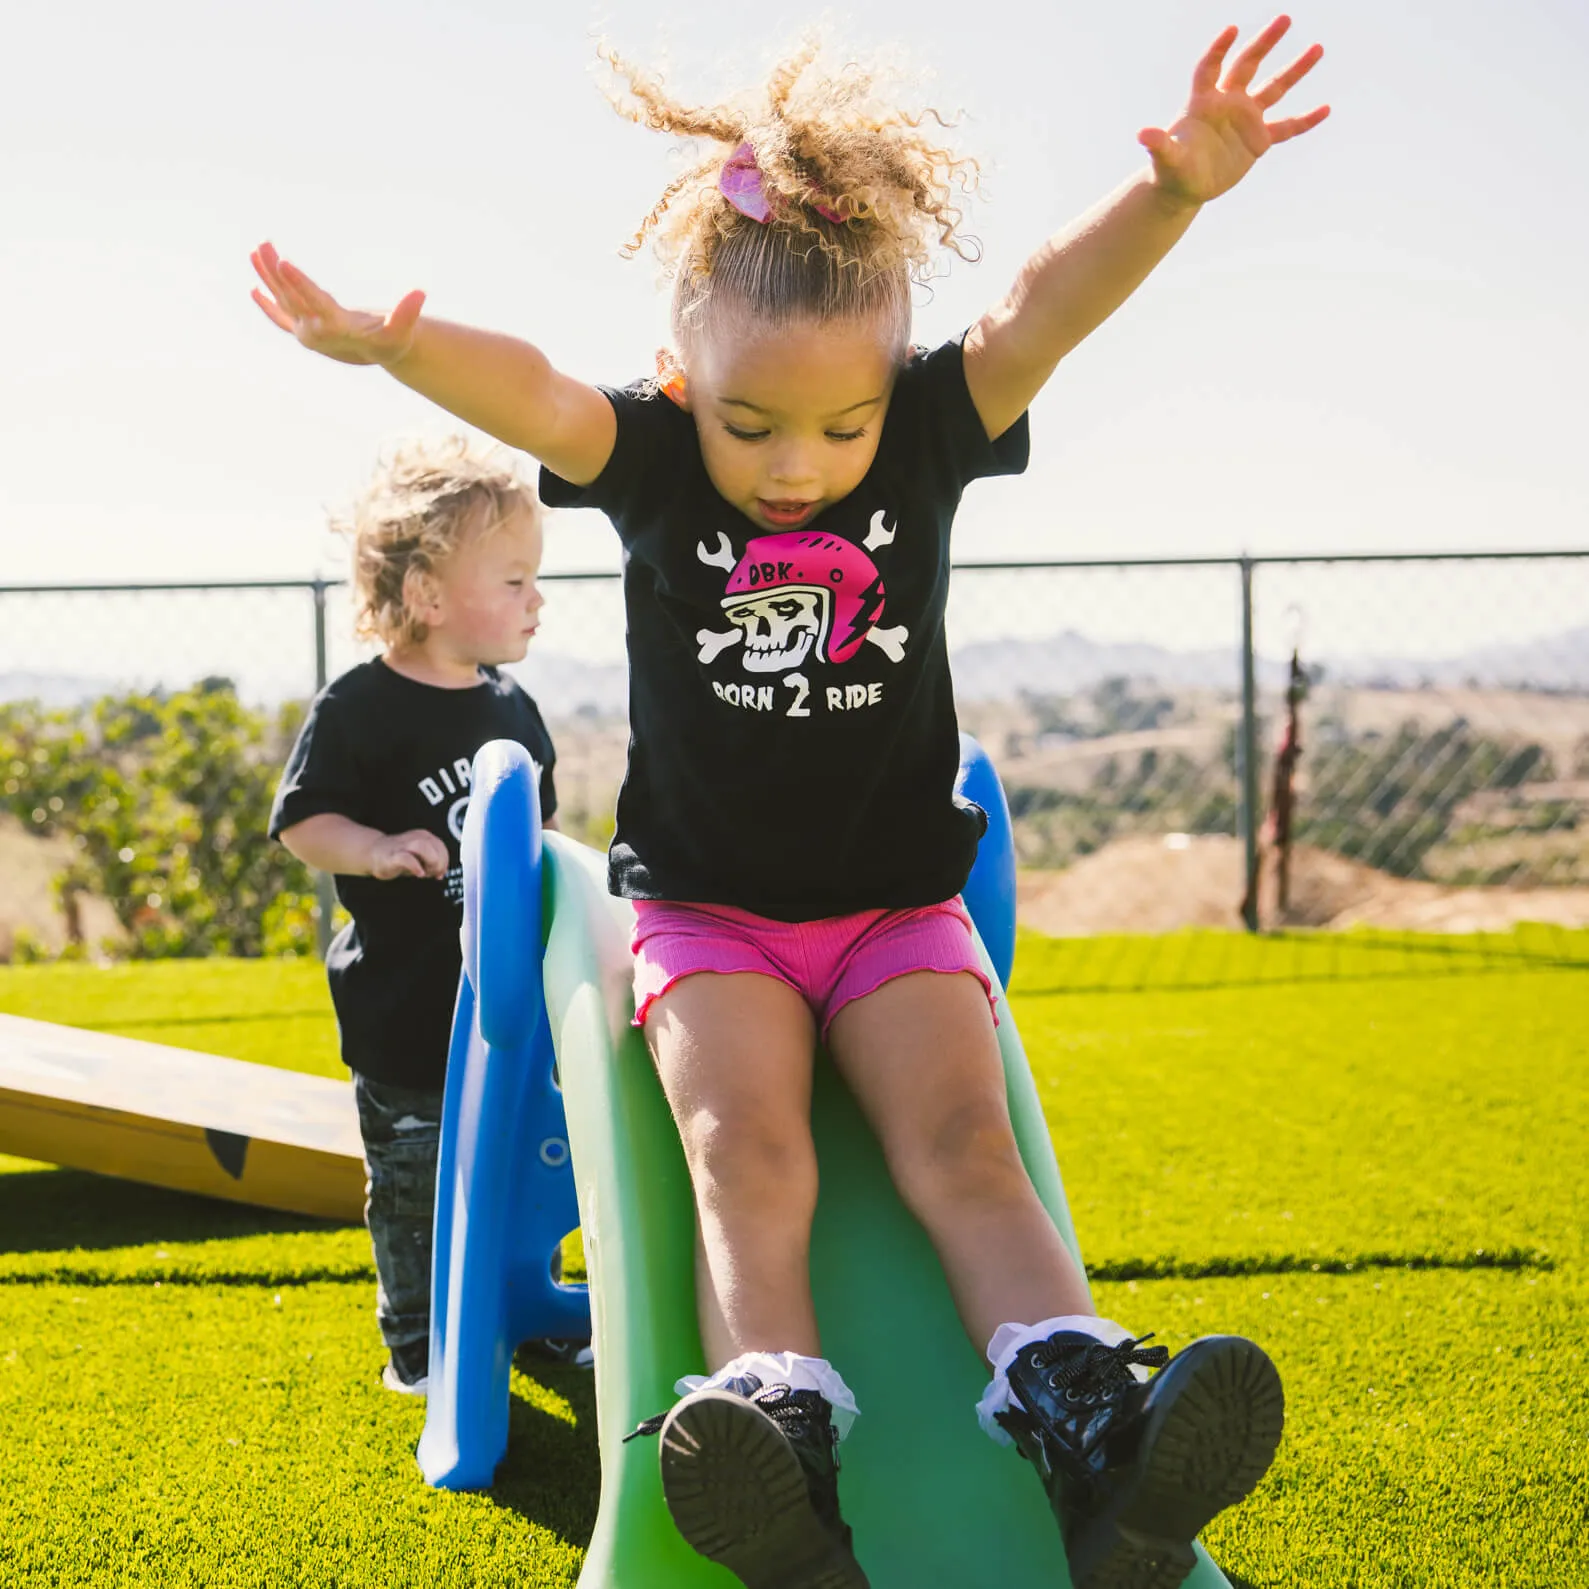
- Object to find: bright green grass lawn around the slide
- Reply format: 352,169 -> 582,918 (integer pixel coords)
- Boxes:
0,934 -> 1589,1589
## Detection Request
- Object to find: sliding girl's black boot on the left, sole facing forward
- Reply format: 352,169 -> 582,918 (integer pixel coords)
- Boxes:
628,1374 -> 868,1589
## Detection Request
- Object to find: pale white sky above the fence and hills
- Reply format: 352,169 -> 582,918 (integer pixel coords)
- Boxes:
0,0 -> 1589,597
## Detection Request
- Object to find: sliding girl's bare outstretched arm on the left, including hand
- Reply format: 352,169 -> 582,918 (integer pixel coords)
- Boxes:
251,243 -> 618,486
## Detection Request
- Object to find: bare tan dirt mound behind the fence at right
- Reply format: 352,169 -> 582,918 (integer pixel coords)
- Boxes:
1015,834 -> 1589,936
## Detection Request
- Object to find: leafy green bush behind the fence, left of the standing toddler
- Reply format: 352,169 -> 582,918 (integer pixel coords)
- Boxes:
0,679 -> 316,958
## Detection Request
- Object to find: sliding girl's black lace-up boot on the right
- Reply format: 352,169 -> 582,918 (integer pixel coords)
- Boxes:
999,1330 -> 1286,1589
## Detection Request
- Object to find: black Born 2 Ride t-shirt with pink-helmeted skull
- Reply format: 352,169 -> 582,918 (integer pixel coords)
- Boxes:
540,340 -> 1028,922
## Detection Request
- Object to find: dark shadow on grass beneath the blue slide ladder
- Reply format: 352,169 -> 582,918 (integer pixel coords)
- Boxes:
486,1360 -> 601,1549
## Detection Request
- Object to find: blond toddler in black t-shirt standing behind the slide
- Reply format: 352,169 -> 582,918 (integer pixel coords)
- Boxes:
270,440 -> 590,1395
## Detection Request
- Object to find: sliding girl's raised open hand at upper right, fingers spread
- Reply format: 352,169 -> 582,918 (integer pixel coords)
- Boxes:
1136,16 -> 1330,205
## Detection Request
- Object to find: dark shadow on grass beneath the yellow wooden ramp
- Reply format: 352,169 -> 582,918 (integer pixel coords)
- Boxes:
0,1168 -> 342,1254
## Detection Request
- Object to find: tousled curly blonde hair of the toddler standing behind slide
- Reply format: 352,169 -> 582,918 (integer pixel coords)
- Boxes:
331,435 -> 540,645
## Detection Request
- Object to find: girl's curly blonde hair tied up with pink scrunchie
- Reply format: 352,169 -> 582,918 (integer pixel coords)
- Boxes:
599,41 -> 980,353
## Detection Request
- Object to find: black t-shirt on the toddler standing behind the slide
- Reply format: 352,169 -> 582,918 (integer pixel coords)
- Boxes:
270,659 -> 558,1087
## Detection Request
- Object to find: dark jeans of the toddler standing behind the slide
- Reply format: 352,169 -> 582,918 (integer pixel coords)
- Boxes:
353,1071 -> 442,1351
